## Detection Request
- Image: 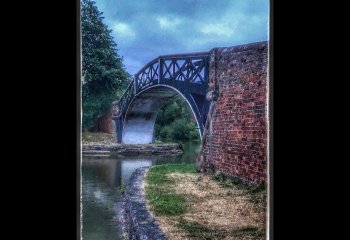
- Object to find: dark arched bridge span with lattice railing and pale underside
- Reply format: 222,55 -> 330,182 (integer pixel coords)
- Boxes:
113,52 -> 209,143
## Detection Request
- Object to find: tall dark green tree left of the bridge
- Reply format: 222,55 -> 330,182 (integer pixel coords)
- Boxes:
81,0 -> 131,129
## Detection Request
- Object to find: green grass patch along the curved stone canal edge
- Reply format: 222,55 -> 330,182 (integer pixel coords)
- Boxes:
145,164 -> 196,216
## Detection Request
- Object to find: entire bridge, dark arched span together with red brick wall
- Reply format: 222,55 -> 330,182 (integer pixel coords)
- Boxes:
112,41 -> 268,183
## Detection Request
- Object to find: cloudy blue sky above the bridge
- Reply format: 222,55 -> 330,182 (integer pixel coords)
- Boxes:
95,0 -> 269,75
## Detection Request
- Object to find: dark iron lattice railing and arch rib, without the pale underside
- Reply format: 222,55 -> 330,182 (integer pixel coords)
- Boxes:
113,52 -> 209,142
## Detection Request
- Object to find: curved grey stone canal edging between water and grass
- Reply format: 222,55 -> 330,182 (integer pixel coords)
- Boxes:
121,167 -> 168,240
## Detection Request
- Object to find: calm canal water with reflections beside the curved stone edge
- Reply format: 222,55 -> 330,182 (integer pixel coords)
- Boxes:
81,143 -> 199,240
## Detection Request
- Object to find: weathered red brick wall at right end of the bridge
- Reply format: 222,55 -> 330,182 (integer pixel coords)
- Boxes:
203,42 -> 268,183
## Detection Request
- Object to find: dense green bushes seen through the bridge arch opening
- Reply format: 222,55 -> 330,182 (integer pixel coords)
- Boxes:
155,96 -> 200,142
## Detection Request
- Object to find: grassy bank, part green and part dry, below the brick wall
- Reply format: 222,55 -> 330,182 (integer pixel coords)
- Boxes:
144,164 -> 266,240
